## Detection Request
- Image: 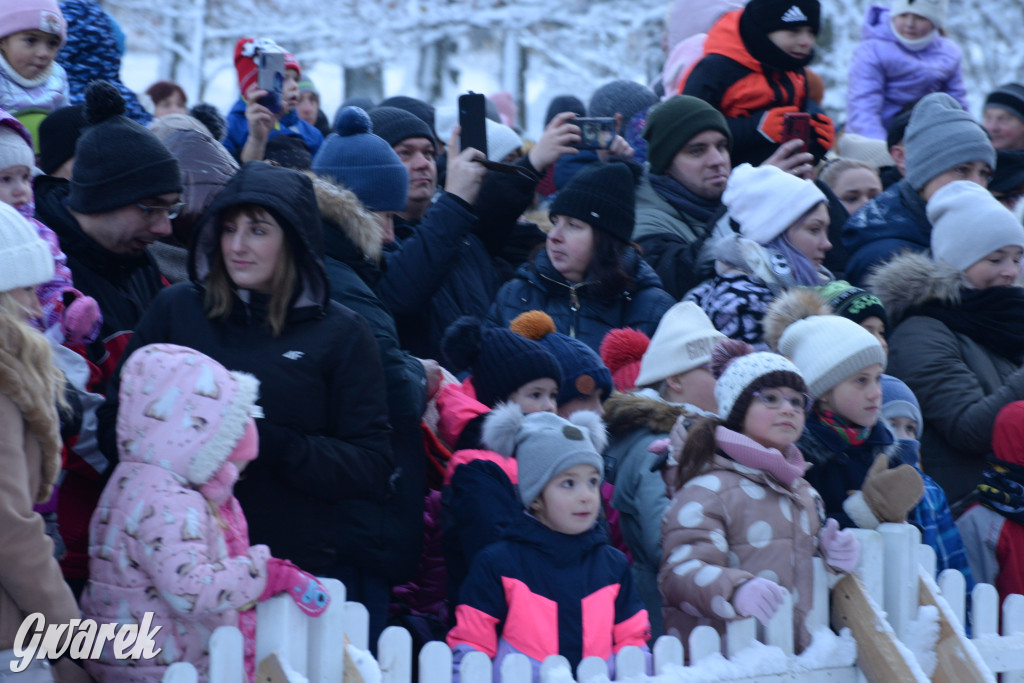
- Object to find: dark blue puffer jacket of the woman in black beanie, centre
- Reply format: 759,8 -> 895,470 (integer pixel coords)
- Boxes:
487,248 -> 676,351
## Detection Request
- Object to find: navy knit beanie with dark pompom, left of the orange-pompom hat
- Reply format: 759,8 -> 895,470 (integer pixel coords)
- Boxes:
441,315 -> 562,408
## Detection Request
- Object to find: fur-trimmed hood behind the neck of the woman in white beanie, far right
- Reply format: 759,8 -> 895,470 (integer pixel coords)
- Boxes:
867,253 -> 968,328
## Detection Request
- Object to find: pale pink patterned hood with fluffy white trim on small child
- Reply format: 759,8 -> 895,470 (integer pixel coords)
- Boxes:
117,344 -> 259,486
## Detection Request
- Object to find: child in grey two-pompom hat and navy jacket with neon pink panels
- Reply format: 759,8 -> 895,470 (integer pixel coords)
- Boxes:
447,405 -> 650,681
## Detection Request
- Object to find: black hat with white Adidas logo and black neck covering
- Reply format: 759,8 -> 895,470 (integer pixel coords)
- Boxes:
739,0 -> 821,71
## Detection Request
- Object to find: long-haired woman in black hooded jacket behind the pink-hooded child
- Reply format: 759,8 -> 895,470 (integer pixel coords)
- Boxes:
103,162 -> 394,582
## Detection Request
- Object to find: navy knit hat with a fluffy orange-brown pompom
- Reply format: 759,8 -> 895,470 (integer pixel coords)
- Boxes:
509,310 -> 611,405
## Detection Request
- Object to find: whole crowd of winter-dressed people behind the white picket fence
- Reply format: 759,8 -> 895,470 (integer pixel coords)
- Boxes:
0,0 -> 1024,681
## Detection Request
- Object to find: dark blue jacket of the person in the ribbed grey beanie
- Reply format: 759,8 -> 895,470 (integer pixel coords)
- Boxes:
843,179 -> 932,287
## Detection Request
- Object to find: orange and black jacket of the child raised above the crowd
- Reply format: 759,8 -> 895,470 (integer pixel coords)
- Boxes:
680,9 -> 820,167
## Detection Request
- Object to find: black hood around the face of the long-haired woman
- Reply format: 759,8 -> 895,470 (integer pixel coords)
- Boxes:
188,162 -> 331,308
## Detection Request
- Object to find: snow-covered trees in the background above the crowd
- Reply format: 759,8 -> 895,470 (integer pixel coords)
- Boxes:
112,0 -> 1024,137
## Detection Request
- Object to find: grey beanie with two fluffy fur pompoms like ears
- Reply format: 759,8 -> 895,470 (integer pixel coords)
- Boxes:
481,403 -> 608,508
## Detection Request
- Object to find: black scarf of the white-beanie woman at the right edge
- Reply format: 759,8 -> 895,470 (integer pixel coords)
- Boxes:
906,287 -> 1024,362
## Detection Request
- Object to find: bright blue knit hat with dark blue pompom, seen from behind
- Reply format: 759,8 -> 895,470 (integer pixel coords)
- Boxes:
313,106 -> 409,211
